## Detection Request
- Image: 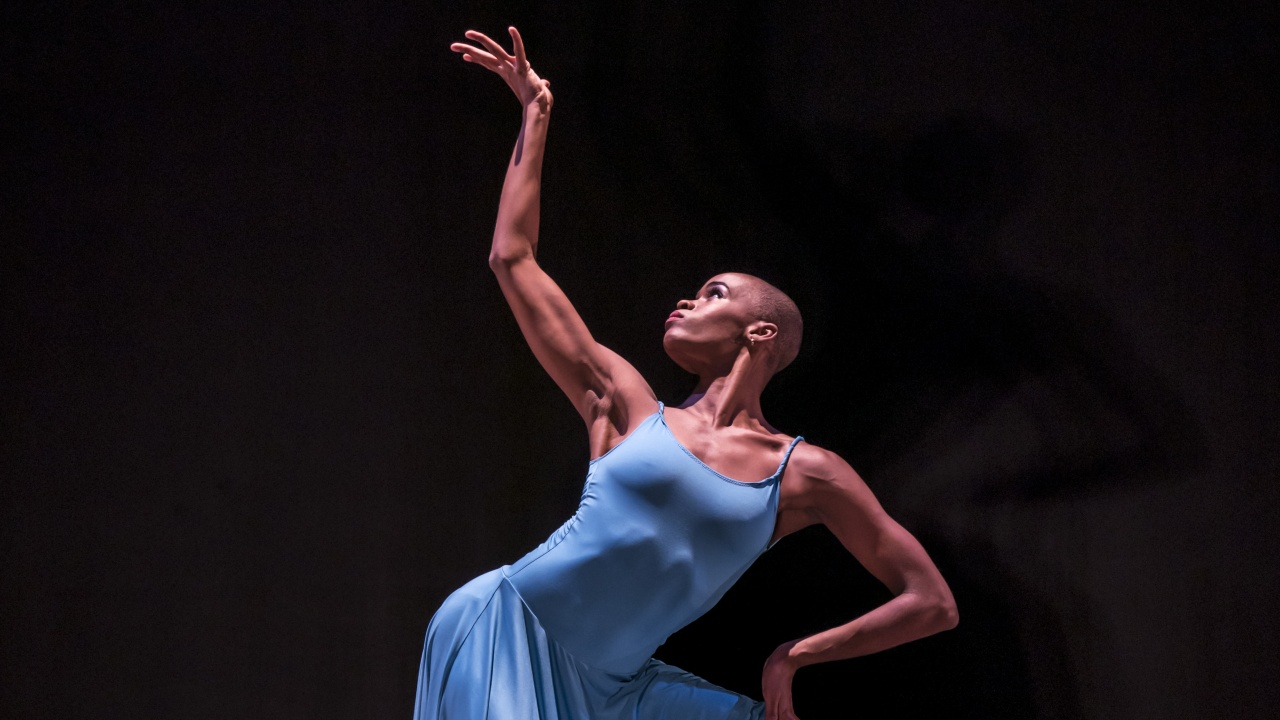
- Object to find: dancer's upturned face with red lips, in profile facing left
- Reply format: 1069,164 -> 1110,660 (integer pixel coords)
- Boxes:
662,273 -> 756,374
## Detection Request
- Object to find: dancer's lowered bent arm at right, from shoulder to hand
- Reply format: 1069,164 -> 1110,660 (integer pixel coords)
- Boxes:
763,446 -> 959,720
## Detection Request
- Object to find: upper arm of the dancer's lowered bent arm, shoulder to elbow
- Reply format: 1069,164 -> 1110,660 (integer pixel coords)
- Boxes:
801,446 -> 954,603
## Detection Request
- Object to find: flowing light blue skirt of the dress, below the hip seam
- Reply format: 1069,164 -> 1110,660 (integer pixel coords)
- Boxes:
413,570 -> 764,720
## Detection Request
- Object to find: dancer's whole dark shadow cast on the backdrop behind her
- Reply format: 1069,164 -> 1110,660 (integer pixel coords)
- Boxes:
659,22 -> 1204,717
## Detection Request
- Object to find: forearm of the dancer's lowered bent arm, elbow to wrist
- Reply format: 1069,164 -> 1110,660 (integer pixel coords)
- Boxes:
786,592 -> 956,669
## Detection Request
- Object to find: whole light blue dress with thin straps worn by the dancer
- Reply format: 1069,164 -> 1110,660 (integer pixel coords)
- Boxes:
413,402 -> 801,720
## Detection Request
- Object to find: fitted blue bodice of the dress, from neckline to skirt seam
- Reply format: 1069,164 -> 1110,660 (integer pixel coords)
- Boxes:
503,402 -> 803,673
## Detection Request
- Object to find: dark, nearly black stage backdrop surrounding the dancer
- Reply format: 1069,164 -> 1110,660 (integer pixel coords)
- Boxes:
0,1 -> 1280,719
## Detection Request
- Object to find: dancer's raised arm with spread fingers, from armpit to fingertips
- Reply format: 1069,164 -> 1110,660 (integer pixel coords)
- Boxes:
451,27 -> 655,435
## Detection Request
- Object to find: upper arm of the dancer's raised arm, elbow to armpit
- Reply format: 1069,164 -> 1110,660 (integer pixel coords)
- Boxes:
490,258 -> 654,427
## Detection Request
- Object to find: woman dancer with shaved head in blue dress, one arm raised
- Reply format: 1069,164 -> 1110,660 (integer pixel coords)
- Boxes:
415,28 -> 956,720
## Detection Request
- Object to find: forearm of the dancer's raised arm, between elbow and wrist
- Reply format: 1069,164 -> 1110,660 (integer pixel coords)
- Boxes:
489,101 -> 550,264
